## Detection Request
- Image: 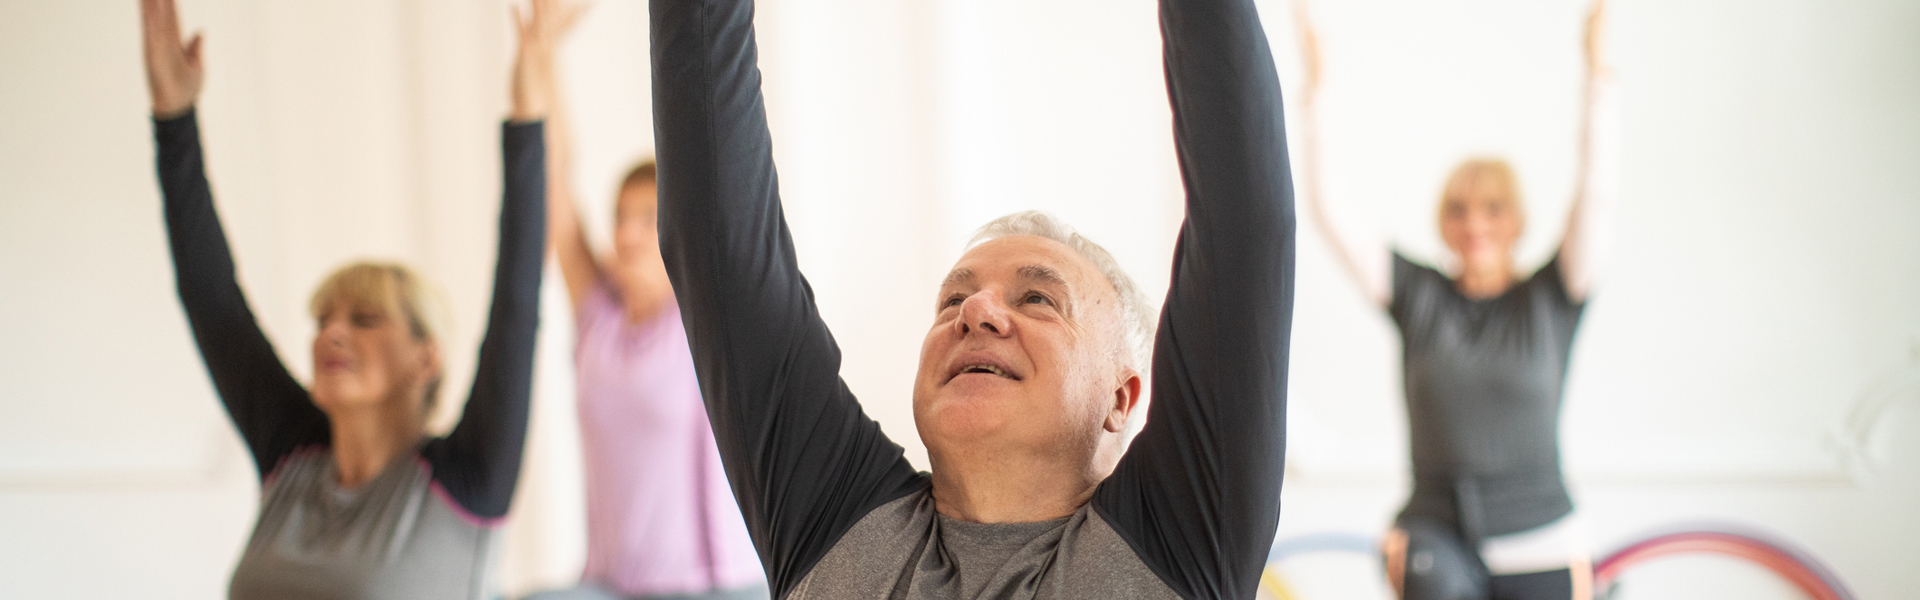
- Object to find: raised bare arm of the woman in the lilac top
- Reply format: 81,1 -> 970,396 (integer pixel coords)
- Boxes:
547,6 -> 601,312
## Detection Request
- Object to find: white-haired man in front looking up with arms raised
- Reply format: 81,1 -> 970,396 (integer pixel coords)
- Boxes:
651,0 -> 1294,598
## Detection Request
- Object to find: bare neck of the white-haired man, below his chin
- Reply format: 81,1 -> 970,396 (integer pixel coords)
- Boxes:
933,448 -> 1106,523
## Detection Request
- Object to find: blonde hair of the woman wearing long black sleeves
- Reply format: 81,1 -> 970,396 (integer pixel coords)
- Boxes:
307,262 -> 451,412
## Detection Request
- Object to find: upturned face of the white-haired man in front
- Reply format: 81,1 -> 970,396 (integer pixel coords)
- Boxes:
914,237 -> 1139,467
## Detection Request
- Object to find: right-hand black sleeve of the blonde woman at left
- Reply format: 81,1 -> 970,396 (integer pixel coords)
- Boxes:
420,123 -> 547,519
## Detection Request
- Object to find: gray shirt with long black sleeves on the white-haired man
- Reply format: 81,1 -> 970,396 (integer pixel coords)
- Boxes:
651,0 -> 1294,598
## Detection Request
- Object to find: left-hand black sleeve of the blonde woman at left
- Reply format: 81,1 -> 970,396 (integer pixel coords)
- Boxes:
154,110 -> 332,477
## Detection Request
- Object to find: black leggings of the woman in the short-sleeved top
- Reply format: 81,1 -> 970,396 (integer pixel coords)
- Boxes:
1400,519 -> 1572,600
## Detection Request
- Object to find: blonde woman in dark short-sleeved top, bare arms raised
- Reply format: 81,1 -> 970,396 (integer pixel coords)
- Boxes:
1296,2 -> 1613,600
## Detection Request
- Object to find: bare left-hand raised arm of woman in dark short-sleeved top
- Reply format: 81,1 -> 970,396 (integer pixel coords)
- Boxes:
1294,2 -> 1392,306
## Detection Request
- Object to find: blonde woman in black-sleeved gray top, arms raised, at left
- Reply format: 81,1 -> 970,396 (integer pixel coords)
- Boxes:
140,0 -> 553,600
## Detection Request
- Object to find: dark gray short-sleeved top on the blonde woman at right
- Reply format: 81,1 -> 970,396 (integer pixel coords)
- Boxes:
1388,252 -> 1582,540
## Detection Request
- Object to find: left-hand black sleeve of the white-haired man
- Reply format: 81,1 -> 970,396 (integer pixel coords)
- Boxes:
651,0 -> 927,598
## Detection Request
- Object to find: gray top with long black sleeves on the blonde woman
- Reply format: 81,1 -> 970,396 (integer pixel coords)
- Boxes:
154,112 -> 547,598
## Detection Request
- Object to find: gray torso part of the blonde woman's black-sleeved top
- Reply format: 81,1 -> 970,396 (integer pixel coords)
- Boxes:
228,450 -> 493,600
